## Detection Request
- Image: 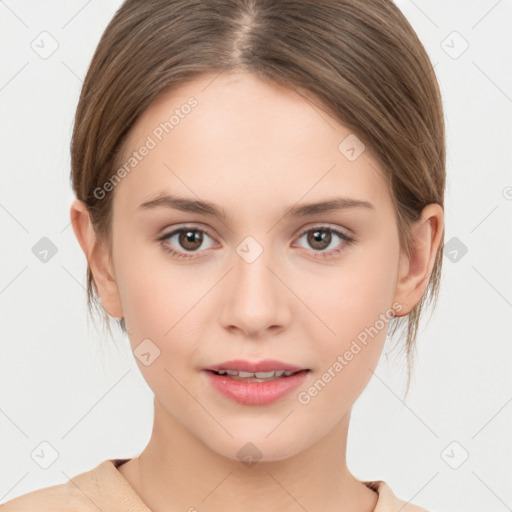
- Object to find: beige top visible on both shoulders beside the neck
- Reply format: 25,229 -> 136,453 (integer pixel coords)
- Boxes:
0,459 -> 427,512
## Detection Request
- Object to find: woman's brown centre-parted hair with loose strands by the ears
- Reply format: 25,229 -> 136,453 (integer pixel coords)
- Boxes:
71,0 -> 445,396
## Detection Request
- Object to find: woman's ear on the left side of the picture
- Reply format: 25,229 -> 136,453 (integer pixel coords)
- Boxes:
70,199 -> 124,318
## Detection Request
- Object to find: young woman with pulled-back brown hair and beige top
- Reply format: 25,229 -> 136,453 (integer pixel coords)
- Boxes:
1,0 -> 445,512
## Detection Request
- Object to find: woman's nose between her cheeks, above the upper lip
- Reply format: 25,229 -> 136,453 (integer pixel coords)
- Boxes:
221,243 -> 293,338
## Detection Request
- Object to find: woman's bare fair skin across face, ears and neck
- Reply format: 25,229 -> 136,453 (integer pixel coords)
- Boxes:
71,73 -> 443,512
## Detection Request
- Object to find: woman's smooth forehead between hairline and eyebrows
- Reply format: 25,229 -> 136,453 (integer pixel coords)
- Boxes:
114,73 -> 391,218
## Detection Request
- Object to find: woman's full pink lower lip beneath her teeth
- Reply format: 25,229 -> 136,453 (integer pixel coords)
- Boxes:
206,370 -> 309,405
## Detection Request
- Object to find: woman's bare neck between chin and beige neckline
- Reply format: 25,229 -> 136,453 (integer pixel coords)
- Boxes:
119,400 -> 378,512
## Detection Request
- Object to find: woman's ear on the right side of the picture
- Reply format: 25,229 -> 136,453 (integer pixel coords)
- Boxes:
395,203 -> 444,316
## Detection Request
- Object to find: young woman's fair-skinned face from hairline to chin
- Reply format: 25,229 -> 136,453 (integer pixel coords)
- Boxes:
85,74 -> 412,460
